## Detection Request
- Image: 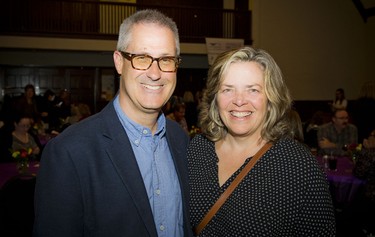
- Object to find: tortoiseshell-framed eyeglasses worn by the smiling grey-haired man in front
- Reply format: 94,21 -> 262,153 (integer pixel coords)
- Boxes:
119,51 -> 181,72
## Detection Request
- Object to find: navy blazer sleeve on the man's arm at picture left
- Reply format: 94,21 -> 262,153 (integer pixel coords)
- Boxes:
34,137 -> 84,237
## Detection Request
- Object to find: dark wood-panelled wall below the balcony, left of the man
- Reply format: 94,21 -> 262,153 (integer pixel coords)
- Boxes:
0,67 -> 100,112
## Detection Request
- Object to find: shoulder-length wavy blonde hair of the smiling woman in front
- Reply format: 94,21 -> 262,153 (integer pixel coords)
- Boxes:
199,47 -> 292,142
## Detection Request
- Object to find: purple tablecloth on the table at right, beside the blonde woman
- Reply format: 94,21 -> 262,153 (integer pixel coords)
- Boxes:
317,156 -> 366,205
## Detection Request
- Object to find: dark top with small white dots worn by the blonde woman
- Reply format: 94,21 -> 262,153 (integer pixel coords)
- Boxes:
188,135 -> 335,237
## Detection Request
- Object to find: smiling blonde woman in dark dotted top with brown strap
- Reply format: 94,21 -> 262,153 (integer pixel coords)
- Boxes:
188,47 -> 335,236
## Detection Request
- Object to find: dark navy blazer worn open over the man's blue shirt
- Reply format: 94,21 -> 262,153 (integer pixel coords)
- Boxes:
34,101 -> 192,237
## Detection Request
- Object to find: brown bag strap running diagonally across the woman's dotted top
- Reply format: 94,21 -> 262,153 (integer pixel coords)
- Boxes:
194,143 -> 272,236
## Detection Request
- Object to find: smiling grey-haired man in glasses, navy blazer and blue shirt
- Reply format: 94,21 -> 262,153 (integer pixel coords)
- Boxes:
34,10 -> 191,237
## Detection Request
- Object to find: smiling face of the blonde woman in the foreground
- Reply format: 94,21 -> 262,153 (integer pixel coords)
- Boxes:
217,62 -> 267,137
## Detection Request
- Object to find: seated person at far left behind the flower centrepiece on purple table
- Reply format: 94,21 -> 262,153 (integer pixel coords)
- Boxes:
11,114 -> 40,161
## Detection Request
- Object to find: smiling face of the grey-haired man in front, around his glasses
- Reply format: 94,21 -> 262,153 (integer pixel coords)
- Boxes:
114,23 -> 176,122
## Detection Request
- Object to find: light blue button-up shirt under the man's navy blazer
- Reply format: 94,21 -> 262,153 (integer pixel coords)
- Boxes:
114,96 -> 183,237
